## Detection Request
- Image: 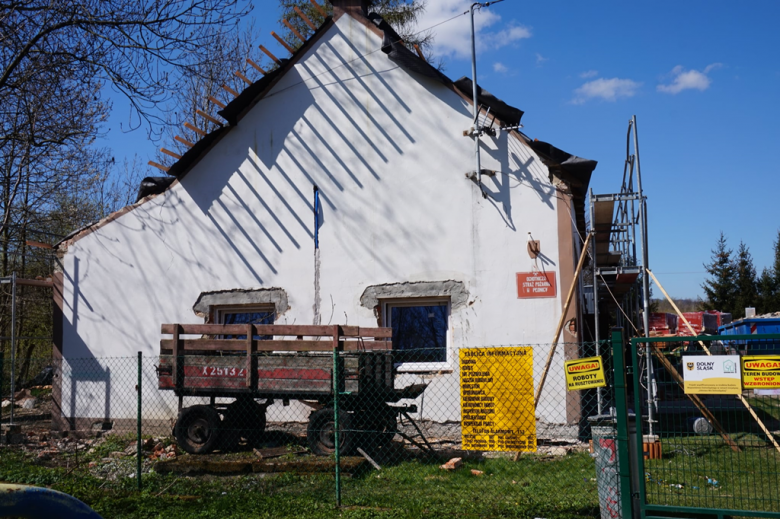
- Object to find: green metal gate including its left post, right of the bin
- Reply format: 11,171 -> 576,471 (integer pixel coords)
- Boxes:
612,329 -> 780,519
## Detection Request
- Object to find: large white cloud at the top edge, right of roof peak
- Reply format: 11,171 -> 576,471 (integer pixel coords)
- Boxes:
417,0 -> 531,59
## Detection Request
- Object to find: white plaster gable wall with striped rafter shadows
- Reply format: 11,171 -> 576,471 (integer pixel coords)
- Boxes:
58,16 -> 565,422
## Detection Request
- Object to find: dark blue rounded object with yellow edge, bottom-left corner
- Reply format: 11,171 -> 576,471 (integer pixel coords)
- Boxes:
0,484 -> 102,519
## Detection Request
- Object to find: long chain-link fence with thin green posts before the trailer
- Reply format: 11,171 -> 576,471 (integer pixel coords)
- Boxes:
0,336 -> 619,517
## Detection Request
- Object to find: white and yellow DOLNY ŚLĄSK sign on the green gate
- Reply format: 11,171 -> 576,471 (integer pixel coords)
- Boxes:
682,355 -> 742,395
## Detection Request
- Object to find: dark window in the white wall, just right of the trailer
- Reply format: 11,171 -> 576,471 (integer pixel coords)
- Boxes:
385,301 -> 448,362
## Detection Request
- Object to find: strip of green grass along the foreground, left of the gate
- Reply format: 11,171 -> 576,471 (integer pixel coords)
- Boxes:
0,448 -> 598,519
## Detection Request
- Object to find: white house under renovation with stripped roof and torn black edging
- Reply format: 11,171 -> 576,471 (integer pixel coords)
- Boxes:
54,0 -> 596,436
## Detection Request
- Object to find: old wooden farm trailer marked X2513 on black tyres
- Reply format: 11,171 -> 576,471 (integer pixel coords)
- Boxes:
158,324 -> 426,455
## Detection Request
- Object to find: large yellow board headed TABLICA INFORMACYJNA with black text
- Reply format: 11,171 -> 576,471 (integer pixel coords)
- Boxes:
460,346 -> 536,452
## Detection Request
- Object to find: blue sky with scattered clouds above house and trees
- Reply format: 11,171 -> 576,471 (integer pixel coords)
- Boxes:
99,0 -> 780,297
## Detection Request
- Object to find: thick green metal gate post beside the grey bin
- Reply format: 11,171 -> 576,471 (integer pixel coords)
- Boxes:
612,328 -> 642,518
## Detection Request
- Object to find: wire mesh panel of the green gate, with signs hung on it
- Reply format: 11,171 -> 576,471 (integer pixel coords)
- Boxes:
632,335 -> 780,517
